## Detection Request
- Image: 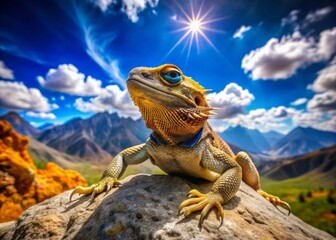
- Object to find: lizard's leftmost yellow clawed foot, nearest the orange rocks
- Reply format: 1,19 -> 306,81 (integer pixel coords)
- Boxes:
70,177 -> 121,204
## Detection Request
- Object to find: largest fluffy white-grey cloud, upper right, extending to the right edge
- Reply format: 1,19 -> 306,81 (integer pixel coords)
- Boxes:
241,28 -> 336,80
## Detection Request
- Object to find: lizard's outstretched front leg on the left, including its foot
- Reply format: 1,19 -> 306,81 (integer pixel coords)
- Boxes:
70,143 -> 148,202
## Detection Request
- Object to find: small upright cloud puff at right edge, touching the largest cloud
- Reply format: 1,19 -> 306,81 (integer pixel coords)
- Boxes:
318,27 -> 336,60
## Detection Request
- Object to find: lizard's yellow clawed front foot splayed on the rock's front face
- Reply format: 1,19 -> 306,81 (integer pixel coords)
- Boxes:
178,189 -> 224,227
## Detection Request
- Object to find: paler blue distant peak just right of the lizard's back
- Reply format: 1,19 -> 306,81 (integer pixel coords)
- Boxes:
219,126 -> 283,152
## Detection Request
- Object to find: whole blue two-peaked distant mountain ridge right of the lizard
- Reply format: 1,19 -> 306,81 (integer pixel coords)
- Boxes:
219,126 -> 336,159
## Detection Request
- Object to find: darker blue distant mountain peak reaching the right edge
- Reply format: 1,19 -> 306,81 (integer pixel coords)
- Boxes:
271,127 -> 336,157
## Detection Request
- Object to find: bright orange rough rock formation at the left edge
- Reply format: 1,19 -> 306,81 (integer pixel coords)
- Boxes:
0,121 -> 86,222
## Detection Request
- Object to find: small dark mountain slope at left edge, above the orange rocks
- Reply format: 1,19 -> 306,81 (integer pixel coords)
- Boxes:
0,112 -> 40,136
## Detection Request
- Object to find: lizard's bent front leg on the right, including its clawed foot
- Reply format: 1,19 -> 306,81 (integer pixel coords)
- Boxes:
179,147 -> 242,227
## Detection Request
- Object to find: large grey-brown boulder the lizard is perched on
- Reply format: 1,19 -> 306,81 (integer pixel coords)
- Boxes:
0,175 -> 333,239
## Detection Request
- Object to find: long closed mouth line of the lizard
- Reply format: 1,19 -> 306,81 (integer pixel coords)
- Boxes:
126,76 -> 197,107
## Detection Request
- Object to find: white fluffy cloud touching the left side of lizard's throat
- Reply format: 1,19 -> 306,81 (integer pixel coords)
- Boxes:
75,85 -> 140,119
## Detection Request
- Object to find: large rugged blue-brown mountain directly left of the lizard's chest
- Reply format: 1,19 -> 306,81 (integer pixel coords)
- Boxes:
37,113 -> 150,161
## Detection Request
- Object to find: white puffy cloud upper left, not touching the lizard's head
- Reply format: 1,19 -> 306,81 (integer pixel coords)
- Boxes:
37,64 -> 102,96
